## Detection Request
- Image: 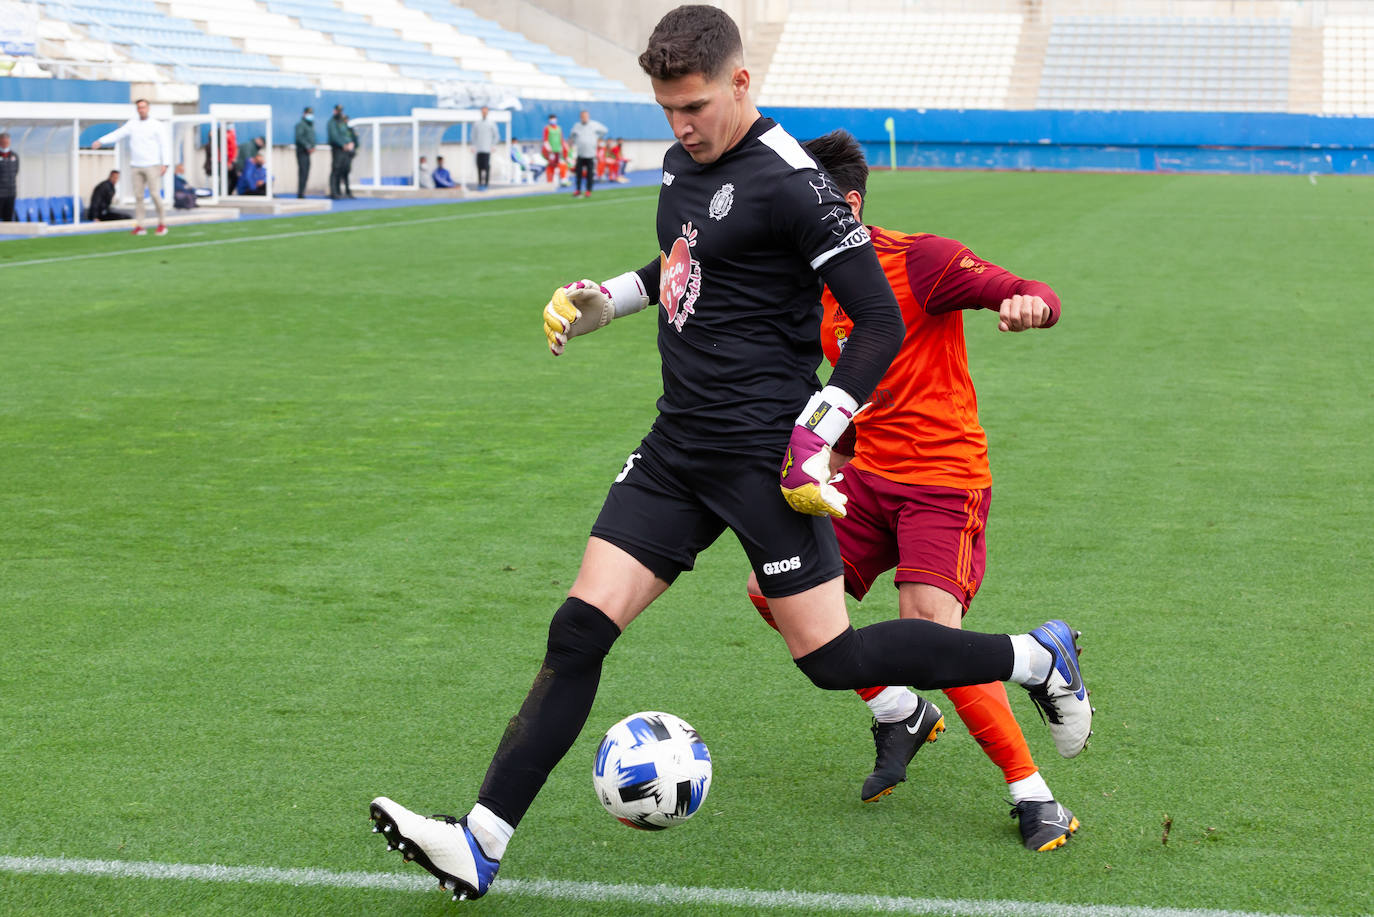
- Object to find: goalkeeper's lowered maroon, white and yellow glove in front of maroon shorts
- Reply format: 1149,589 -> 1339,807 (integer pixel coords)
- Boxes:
782,385 -> 859,517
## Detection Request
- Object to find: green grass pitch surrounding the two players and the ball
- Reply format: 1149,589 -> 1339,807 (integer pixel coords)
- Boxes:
0,173 -> 1374,917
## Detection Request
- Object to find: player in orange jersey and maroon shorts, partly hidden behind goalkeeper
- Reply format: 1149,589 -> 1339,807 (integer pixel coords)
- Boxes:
749,131 -> 1079,851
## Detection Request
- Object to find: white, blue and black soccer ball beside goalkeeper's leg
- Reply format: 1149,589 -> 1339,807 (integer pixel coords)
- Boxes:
592,711 -> 710,830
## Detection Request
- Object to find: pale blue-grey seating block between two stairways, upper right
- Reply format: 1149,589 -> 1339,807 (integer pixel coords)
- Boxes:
1037,16 -> 1292,111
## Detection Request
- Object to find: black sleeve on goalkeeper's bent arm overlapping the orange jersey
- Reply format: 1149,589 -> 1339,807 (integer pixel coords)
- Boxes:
820,246 -> 907,404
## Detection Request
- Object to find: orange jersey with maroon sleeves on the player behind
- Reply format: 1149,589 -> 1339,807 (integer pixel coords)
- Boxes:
820,227 -> 1059,489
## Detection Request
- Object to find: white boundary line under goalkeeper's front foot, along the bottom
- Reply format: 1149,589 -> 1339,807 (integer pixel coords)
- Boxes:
0,857 -> 1330,917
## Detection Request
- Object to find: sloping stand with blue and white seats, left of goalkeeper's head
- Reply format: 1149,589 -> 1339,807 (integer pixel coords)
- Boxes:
24,0 -> 649,102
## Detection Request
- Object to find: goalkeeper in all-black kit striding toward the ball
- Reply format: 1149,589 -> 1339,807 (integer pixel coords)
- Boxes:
370,5 -> 1091,898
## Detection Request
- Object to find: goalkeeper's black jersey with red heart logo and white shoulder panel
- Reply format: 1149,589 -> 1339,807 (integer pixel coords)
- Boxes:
639,118 -> 900,452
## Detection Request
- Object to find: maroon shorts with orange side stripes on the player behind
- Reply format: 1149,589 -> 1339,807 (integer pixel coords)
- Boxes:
834,465 -> 992,610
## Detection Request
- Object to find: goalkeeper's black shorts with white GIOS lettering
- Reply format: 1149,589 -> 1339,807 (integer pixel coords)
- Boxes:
592,432 -> 842,598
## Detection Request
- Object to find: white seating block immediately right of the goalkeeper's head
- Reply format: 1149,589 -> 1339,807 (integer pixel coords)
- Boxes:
758,12 -> 1021,109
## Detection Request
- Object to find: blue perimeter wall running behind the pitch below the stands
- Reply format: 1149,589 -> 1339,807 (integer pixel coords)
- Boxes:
0,77 -> 1374,175
